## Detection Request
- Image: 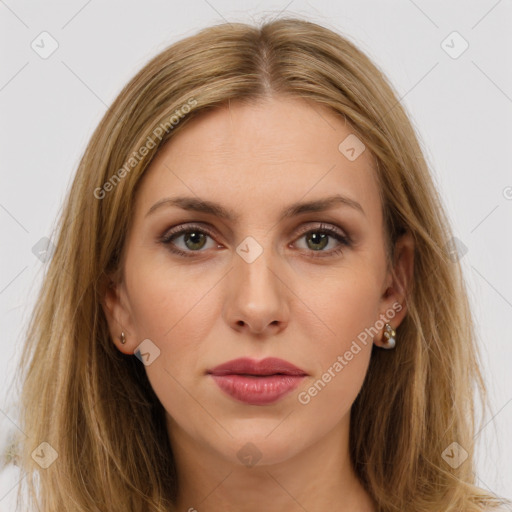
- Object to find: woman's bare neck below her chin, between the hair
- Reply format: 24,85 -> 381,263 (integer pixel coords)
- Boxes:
169,418 -> 377,512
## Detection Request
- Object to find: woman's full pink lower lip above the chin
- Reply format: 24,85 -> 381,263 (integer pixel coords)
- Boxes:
208,374 -> 304,405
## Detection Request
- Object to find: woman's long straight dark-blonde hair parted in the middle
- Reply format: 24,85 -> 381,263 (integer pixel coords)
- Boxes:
15,19 -> 508,512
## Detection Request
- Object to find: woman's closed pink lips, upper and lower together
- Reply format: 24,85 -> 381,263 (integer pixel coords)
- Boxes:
207,357 -> 308,405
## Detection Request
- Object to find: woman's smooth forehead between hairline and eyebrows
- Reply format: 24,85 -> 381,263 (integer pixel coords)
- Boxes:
132,97 -> 380,224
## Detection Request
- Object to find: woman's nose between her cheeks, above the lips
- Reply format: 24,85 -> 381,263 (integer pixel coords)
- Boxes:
224,243 -> 290,335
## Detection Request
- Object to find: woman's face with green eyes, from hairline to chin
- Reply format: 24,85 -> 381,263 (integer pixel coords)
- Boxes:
102,97 -> 405,464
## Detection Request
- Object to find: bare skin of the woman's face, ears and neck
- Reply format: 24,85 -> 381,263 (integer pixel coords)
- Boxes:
104,97 -> 413,512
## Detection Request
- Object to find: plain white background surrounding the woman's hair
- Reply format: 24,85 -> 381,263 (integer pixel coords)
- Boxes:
0,0 -> 512,510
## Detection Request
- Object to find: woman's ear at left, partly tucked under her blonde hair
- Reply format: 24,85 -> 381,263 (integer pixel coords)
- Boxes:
101,276 -> 137,354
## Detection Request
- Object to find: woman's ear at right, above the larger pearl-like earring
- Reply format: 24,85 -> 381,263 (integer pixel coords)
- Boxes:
375,231 -> 415,346
